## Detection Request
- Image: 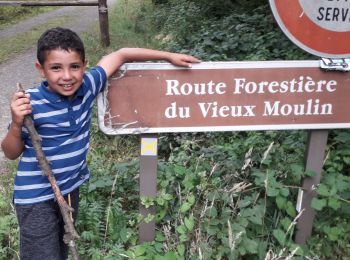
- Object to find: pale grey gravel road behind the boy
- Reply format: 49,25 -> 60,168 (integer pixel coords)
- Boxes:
0,0 -> 117,173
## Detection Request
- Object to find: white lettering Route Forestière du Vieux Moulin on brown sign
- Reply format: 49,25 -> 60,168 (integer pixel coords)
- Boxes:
164,75 -> 340,119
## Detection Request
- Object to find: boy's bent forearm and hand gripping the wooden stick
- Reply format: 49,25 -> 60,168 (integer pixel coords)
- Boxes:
1,92 -> 32,160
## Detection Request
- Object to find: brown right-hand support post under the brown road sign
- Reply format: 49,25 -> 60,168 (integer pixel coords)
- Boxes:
295,130 -> 328,245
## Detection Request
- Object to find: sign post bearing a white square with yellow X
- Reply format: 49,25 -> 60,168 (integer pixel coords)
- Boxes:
139,134 -> 158,243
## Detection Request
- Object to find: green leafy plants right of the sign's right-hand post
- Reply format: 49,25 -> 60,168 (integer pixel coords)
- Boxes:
310,130 -> 350,259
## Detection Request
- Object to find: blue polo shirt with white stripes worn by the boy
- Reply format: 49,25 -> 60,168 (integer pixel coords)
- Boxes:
14,67 -> 107,204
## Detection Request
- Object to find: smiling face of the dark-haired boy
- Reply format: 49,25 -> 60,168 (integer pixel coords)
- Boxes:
36,49 -> 86,99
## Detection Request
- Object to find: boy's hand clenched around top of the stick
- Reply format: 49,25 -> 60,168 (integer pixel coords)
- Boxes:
11,91 -> 32,127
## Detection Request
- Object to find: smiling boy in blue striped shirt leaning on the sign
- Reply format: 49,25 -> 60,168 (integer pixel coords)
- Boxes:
1,27 -> 199,260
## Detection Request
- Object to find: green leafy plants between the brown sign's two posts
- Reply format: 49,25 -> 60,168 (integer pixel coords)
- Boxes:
152,131 -> 305,259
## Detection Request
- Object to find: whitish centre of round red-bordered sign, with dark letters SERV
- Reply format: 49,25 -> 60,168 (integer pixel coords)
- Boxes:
299,0 -> 350,32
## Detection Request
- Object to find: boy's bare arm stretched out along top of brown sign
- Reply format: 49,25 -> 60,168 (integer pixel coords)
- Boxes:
97,48 -> 200,77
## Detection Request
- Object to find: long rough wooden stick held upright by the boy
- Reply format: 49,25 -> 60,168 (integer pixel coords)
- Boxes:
17,83 -> 80,260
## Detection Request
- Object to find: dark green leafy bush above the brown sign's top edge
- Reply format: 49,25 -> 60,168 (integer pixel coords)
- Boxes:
156,1 -> 312,61
